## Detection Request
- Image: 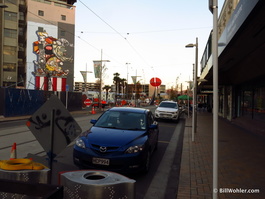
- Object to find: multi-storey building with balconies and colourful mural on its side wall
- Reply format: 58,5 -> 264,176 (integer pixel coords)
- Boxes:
0,0 -> 76,90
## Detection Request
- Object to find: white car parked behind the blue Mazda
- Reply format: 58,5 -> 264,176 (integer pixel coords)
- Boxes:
155,101 -> 180,121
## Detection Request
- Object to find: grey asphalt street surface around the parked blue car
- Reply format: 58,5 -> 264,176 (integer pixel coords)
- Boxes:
0,107 -> 184,199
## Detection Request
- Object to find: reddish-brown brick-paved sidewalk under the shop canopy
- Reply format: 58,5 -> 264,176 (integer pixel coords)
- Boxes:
177,112 -> 265,199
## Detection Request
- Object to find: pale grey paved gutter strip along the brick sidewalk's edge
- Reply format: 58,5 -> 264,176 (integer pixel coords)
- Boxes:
144,120 -> 182,199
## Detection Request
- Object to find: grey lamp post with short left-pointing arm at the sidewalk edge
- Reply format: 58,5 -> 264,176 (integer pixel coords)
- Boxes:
185,37 -> 198,142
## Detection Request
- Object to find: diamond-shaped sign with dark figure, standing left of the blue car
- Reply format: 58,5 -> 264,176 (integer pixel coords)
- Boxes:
26,95 -> 82,156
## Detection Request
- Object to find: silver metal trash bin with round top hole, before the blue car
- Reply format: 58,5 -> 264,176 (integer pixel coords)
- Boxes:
59,170 -> 135,199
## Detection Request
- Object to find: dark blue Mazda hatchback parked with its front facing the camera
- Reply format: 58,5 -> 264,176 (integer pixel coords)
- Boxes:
73,107 -> 159,173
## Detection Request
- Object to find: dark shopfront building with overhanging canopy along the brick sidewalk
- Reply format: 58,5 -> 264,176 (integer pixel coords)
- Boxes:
199,0 -> 265,135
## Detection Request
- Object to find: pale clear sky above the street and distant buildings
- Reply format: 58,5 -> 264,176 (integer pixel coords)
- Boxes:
74,0 -> 224,89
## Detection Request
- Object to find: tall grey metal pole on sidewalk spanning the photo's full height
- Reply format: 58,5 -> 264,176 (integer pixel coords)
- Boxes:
212,0 -> 218,199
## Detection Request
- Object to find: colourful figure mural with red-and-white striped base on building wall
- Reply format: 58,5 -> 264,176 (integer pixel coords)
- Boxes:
33,29 -> 73,91
